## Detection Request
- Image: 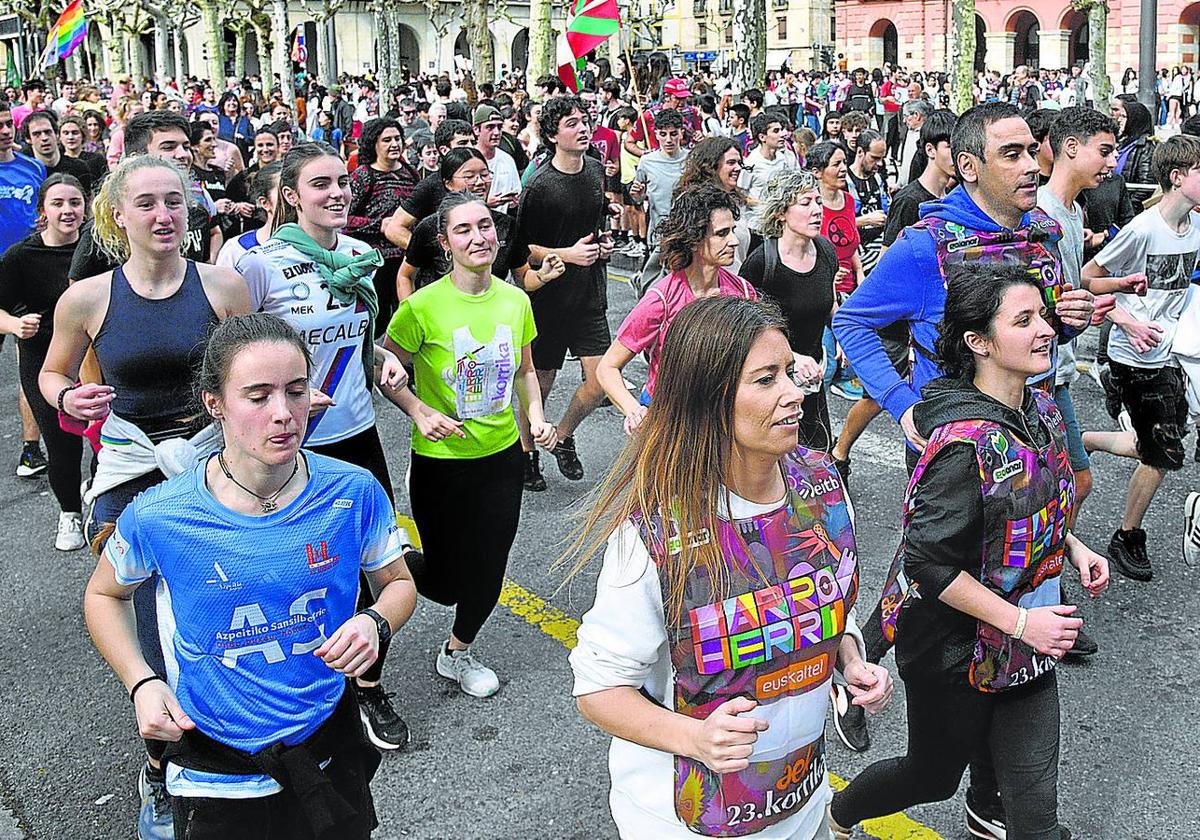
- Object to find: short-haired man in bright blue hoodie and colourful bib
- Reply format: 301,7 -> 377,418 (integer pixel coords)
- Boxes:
833,102 -> 1092,456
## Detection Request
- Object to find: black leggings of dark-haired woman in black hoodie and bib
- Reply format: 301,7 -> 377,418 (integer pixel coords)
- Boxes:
833,671 -> 1060,840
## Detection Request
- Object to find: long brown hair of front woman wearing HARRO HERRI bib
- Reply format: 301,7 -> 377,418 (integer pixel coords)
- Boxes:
556,296 -> 787,626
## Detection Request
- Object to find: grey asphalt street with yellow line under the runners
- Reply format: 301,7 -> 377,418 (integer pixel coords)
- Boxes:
0,271 -> 1200,840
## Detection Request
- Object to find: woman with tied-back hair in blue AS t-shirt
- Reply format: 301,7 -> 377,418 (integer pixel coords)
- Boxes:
84,314 -> 416,839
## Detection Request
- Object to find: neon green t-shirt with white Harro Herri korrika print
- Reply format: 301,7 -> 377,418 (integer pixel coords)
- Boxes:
388,276 -> 538,458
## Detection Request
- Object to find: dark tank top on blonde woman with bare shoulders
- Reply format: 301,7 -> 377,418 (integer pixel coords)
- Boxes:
92,260 -> 217,442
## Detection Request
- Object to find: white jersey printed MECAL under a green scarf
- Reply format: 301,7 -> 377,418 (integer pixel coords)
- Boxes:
236,235 -> 374,446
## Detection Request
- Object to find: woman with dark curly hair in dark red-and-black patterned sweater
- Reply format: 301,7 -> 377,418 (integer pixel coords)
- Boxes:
346,118 -> 419,338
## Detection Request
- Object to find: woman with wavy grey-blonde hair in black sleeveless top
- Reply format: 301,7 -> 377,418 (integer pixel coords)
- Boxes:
742,169 -> 838,451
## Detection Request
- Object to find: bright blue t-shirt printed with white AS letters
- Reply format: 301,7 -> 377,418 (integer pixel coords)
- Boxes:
104,452 -> 402,798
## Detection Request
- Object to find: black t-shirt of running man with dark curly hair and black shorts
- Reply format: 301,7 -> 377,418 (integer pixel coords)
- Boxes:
517,156 -> 608,317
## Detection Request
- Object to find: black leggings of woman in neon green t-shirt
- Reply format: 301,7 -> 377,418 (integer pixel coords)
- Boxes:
409,443 -> 524,644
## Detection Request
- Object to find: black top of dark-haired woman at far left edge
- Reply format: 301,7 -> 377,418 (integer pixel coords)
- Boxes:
0,233 -> 74,352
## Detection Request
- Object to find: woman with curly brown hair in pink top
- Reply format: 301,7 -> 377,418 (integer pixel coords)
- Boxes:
596,184 -> 758,434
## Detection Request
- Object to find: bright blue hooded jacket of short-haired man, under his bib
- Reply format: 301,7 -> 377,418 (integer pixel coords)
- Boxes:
833,186 -> 1074,420
